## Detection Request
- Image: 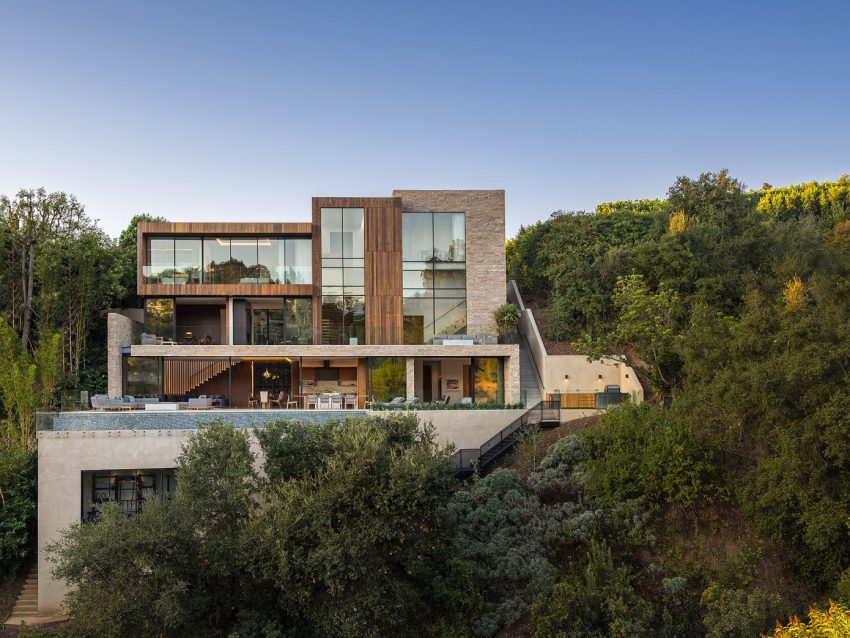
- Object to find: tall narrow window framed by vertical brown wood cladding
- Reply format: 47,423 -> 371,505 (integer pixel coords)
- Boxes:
321,208 -> 366,345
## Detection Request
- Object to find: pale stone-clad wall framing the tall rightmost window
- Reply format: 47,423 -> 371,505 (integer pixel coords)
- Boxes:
393,190 -> 506,334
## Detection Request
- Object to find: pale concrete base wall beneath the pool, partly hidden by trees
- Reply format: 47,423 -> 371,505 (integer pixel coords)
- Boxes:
38,410 -> 523,614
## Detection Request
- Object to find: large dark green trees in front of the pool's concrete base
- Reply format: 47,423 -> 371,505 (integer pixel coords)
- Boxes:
50,415 -> 471,638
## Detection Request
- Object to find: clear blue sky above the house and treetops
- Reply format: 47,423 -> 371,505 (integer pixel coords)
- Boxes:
0,0 -> 850,240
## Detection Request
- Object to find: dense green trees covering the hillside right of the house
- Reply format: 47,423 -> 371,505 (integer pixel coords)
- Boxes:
508,171 -> 850,636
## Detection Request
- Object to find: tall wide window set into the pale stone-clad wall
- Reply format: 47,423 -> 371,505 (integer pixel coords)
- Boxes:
402,213 -> 466,344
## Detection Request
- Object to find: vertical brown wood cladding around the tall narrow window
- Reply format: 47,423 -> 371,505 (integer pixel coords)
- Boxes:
313,197 -> 403,344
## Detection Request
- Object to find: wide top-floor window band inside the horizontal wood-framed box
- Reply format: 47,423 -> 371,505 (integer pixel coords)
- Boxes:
143,236 -> 313,284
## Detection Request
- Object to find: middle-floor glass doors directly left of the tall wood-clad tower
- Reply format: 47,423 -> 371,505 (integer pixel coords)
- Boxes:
248,297 -> 313,345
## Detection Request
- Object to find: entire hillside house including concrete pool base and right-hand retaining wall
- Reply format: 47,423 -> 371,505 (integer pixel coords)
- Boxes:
25,190 -> 643,615
